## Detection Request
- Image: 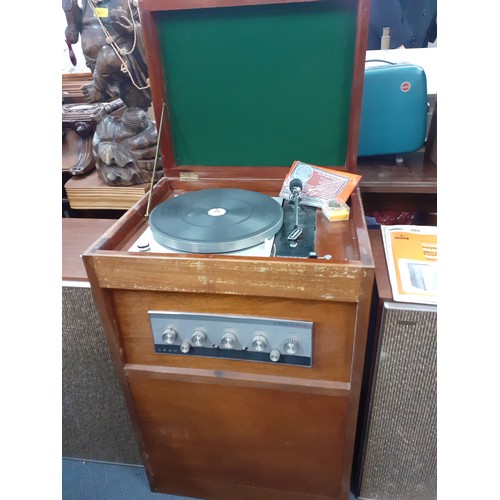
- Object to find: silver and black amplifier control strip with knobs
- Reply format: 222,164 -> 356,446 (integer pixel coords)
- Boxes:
148,311 -> 313,367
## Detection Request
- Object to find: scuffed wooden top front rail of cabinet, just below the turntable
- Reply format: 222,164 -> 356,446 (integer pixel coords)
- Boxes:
94,252 -> 365,302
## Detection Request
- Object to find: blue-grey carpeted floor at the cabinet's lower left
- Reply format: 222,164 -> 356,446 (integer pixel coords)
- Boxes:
62,458 -> 356,500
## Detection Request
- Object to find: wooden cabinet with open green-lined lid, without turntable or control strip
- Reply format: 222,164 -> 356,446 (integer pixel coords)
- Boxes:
83,0 -> 374,500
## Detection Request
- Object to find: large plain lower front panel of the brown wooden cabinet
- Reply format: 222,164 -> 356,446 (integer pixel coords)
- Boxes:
128,373 -> 348,500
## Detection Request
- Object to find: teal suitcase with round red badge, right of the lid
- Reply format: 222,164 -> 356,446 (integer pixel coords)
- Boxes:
358,61 -> 428,156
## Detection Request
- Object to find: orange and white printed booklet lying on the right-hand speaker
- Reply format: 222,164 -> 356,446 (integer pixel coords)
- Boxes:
380,225 -> 437,305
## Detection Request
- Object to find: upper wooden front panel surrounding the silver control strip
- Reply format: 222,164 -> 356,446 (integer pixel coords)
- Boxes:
109,290 -> 357,383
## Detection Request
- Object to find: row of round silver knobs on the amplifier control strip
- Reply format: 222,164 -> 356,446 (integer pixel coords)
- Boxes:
162,328 -> 299,362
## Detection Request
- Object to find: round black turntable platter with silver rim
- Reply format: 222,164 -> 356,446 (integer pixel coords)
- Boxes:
149,189 -> 283,253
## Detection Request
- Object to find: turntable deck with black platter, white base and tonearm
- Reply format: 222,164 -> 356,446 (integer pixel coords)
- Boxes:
129,188 -> 320,258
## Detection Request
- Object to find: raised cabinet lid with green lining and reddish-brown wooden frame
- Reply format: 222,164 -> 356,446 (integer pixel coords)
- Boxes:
139,0 -> 369,177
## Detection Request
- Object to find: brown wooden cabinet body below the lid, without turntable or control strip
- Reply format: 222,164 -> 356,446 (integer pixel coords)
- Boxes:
83,179 -> 374,500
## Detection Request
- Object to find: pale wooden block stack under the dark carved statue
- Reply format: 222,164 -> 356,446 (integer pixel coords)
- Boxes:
64,170 -> 150,210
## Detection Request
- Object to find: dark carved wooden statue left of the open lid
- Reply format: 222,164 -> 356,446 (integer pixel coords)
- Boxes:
62,0 -> 162,186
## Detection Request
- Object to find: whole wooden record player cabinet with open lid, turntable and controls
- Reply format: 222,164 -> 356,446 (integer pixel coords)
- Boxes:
83,0 -> 374,500
